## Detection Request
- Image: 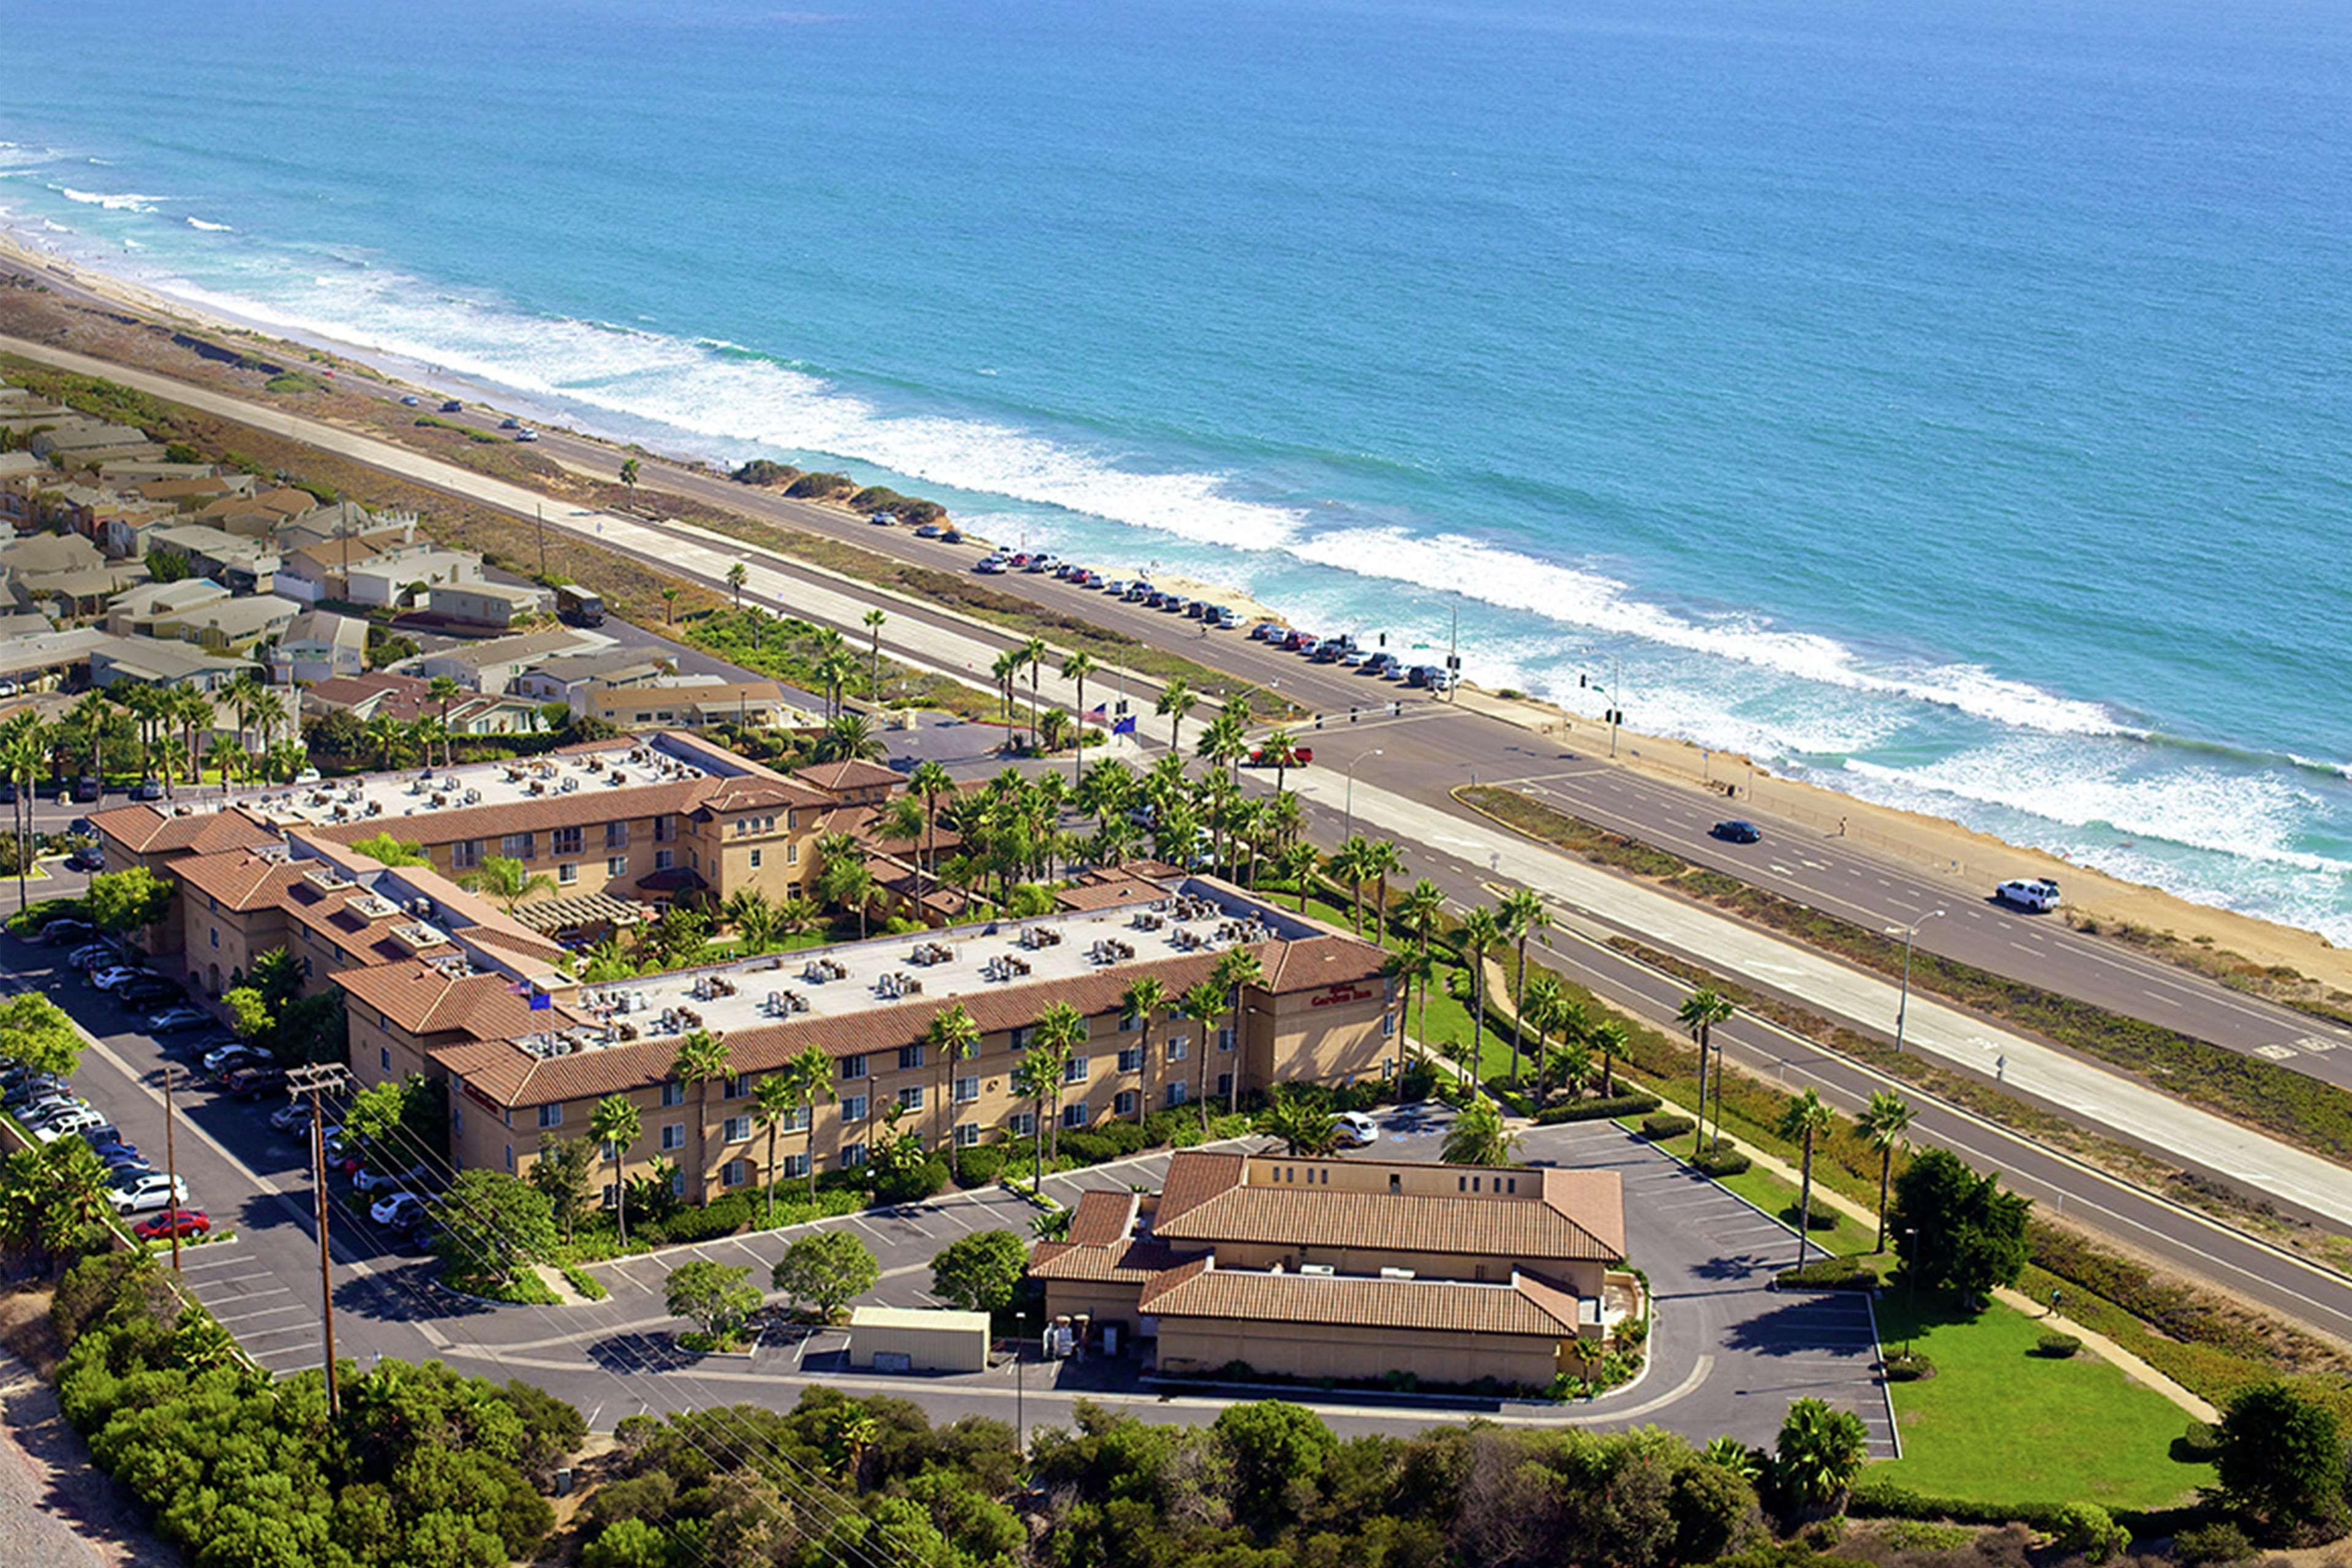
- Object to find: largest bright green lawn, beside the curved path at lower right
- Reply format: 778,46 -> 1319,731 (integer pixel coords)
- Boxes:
1870,1291 -> 2213,1507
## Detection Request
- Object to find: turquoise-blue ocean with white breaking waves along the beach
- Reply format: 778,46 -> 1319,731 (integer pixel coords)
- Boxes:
0,0 -> 2352,940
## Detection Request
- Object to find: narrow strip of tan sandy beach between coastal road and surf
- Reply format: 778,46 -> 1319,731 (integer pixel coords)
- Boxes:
0,224 -> 2352,990
